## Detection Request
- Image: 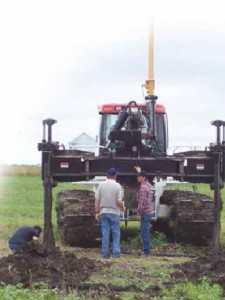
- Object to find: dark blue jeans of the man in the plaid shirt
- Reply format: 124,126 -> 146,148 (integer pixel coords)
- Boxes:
140,213 -> 152,255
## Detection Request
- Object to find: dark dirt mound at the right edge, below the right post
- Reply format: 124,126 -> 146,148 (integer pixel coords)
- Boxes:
171,250 -> 225,291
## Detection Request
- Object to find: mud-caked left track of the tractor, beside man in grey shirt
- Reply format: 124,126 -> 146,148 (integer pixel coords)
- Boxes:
57,190 -> 101,248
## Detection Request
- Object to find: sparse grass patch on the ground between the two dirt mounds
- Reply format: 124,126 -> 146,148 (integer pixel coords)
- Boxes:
90,255 -> 182,292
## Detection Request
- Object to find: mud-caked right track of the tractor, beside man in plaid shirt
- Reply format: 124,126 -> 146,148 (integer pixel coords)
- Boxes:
161,190 -> 214,245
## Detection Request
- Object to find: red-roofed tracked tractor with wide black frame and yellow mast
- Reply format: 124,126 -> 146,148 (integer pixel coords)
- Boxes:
38,31 -> 225,251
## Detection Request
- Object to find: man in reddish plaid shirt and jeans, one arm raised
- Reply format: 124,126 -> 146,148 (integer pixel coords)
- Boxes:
135,167 -> 152,256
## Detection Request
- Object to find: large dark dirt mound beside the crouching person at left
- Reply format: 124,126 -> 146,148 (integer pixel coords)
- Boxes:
0,242 -> 95,289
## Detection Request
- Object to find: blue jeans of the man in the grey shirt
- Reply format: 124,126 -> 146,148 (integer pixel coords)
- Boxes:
100,213 -> 120,259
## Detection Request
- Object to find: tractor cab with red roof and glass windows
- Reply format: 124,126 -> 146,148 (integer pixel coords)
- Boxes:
99,101 -> 168,157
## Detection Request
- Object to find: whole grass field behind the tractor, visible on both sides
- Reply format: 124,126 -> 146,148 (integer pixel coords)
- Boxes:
0,166 -> 225,244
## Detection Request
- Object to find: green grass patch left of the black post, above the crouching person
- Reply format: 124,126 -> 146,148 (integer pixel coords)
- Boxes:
0,176 -> 43,235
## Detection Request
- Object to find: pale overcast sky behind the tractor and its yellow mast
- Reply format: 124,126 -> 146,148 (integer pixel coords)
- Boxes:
0,0 -> 225,164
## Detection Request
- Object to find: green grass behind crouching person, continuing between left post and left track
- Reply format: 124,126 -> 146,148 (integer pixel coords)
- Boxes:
0,175 -> 90,239
